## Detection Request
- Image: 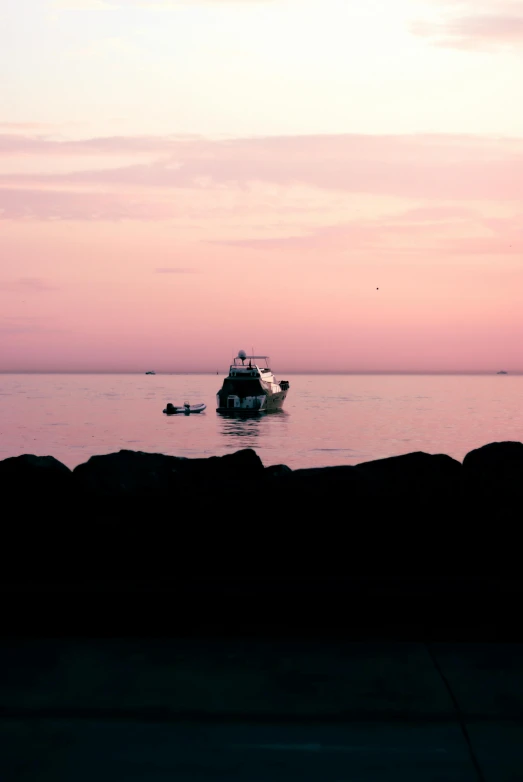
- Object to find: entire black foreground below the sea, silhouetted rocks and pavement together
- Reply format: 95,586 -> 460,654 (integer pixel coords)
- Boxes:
0,443 -> 523,782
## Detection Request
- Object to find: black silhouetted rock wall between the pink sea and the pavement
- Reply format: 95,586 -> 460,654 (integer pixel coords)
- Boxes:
0,442 -> 523,637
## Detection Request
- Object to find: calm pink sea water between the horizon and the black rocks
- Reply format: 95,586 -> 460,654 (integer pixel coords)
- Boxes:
0,374 -> 523,469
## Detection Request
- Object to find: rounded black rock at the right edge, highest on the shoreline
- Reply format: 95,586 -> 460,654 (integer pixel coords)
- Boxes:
463,441 -> 523,503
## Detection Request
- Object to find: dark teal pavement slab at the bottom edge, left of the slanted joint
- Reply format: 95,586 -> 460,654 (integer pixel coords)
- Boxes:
0,720 -> 474,782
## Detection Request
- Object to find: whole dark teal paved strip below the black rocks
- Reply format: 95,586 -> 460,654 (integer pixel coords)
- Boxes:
0,639 -> 523,782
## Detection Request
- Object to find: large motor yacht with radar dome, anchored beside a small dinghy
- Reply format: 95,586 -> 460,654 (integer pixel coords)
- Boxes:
216,350 -> 289,413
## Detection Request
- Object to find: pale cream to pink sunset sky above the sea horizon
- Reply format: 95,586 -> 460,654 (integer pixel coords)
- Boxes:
0,0 -> 523,375
